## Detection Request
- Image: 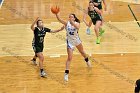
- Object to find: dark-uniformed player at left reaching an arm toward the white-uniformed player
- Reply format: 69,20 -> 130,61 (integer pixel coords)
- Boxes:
31,17 -> 64,77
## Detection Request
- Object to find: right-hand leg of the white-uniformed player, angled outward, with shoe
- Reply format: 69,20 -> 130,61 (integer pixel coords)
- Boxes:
76,43 -> 91,67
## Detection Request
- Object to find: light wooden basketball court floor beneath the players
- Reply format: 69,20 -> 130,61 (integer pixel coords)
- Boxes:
0,0 -> 140,93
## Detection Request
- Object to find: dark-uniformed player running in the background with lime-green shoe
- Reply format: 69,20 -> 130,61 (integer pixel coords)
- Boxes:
83,1 -> 102,44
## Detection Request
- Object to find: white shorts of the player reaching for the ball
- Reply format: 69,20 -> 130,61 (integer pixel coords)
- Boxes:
67,38 -> 82,49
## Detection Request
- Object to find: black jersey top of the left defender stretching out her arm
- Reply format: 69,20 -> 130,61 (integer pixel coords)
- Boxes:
33,27 -> 51,46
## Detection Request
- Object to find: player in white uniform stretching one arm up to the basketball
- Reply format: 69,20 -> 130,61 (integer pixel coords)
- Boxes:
53,14 -> 91,81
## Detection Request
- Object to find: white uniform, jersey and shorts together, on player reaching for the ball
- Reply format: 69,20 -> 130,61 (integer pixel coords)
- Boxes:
66,21 -> 81,49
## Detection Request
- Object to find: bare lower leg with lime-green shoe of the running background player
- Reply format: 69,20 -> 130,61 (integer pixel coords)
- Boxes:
94,20 -> 102,44
